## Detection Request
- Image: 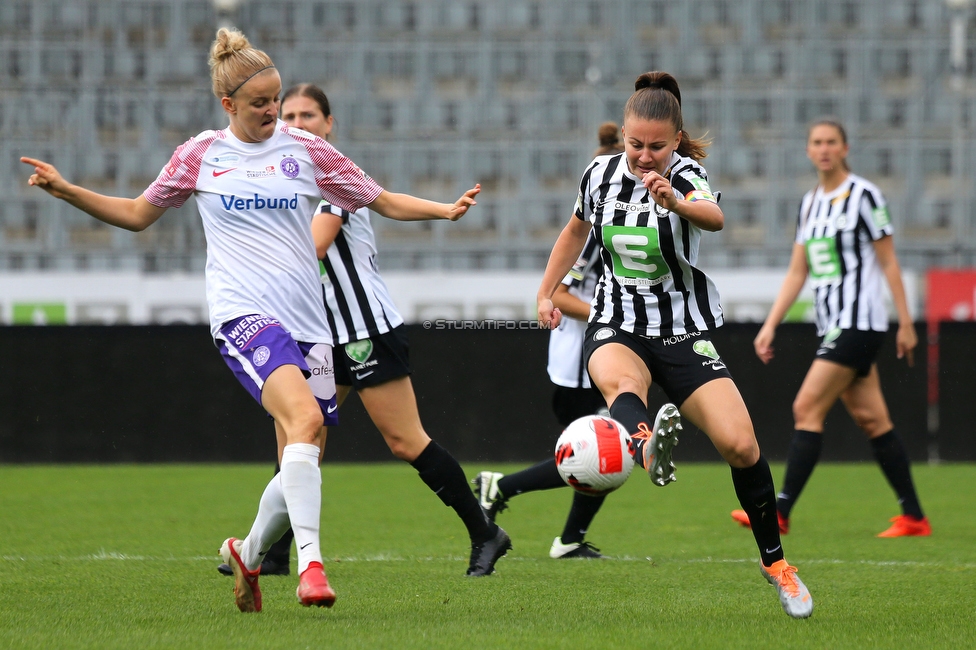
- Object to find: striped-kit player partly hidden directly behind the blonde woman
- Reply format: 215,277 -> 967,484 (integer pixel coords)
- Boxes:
272,84 -> 511,576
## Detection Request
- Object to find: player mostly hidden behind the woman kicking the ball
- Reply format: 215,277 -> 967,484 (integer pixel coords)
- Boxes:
471,122 -> 680,559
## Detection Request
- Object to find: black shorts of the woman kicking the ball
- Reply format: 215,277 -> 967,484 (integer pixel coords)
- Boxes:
583,323 -> 732,407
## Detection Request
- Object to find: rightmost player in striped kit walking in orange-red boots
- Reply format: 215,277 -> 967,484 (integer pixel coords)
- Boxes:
732,119 -> 931,537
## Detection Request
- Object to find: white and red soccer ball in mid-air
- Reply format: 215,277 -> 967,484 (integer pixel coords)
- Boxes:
556,415 -> 634,496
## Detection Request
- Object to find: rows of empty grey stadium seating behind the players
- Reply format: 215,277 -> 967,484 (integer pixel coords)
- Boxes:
0,0 -> 976,272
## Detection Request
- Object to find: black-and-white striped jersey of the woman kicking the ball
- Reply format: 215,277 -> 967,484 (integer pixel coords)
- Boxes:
575,153 -> 724,337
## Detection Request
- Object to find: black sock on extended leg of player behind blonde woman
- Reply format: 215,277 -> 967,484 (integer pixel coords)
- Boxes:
410,440 -> 496,543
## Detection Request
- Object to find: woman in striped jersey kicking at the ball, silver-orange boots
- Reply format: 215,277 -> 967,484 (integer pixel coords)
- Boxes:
538,72 -> 813,618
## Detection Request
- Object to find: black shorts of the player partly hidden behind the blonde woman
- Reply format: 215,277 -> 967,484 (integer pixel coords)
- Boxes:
332,325 -> 410,390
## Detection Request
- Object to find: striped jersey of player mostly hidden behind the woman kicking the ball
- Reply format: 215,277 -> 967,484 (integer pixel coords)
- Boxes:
548,232 -> 603,388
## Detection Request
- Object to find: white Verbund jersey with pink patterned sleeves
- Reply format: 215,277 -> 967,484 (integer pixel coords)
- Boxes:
144,120 -> 383,342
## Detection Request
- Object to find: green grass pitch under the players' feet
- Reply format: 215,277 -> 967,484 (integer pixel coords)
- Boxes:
0,464 -> 976,649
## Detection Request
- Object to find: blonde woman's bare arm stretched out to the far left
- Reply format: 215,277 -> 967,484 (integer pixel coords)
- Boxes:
20,157 -> 166,231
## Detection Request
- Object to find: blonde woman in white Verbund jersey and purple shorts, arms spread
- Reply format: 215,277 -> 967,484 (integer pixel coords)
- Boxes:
21,29 -> 479,612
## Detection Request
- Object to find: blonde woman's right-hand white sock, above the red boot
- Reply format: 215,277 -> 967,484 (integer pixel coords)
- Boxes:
280,443 -> 322,575
